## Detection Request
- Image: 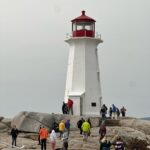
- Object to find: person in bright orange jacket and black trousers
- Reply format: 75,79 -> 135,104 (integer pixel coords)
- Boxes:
40,126 -> 48,150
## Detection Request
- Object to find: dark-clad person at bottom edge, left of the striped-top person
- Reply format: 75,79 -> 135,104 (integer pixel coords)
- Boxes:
100,136 -> 111,150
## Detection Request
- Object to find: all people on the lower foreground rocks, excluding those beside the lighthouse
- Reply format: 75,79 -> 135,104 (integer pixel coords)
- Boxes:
11,118 -> 124,150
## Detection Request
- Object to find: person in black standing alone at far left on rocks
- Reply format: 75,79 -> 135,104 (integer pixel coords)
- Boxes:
10,125 -> 18,148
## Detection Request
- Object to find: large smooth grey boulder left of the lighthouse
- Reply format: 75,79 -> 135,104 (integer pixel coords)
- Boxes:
11,111 -> 54,133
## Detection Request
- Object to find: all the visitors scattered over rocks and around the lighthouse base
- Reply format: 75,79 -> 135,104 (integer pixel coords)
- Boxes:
11,102 -> 126,150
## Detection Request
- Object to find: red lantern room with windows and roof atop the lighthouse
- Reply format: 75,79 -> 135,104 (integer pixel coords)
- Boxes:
71,11 -> 96,37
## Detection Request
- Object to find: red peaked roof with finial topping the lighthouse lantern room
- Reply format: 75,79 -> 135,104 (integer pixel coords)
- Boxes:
71,10 -> 96,23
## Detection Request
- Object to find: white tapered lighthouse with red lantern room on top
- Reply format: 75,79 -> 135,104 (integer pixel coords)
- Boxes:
64,11 -> 103,115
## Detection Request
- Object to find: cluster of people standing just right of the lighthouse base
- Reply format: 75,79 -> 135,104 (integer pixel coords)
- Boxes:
100,104 -> 126,119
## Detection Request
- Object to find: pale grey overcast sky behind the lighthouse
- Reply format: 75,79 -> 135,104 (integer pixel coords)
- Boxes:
0,0 -> 150,117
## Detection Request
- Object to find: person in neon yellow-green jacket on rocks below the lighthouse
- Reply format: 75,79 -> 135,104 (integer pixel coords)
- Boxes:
81,120 -> 90,142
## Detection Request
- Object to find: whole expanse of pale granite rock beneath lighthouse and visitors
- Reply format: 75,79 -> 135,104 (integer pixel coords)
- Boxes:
0,112 -> 150,150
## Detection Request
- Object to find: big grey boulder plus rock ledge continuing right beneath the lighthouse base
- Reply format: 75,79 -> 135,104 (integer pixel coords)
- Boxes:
12,111 -> 100,133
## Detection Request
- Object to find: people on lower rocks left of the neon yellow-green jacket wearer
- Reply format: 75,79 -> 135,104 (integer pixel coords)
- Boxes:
10,123 -> 67,150
